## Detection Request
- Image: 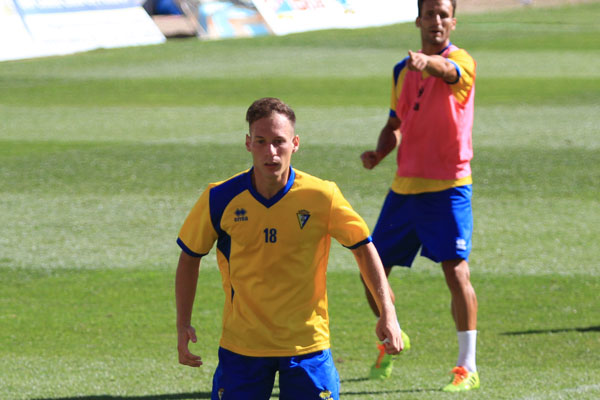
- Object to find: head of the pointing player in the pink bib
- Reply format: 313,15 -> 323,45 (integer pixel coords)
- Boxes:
417,0 -> 456,50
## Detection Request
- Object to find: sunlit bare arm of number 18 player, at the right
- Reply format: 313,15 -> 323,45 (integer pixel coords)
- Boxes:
352,243 -> 404,354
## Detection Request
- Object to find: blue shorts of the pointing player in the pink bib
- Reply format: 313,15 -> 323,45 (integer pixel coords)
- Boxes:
373,185 -> 473,267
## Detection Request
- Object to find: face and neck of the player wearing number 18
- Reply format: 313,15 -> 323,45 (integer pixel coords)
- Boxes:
246,113 -> 300,184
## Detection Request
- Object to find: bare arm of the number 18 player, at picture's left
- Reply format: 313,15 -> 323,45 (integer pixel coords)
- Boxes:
175,251 -> 202,367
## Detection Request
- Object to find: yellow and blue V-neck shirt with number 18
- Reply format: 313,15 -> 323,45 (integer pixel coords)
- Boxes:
177,168 -> 371,357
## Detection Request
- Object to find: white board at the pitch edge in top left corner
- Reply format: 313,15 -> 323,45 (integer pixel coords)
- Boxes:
0,0 -> 166,61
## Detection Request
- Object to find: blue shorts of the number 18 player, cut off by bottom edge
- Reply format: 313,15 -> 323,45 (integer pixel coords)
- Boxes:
211,347 -> 340,400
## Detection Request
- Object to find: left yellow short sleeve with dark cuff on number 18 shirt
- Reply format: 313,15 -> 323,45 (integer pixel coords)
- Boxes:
177,187 -> 218,257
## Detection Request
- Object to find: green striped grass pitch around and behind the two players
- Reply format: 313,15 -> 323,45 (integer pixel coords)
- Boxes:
0,3 -> 600,400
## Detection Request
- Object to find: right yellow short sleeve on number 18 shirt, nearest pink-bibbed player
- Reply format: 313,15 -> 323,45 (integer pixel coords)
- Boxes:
329,183 -> 371,249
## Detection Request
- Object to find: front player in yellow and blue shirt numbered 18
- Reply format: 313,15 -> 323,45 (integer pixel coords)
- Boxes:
175,98 -> 403,400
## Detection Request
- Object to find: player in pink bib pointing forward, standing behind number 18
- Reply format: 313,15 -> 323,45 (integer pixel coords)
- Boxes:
361,0 -> 479,391
